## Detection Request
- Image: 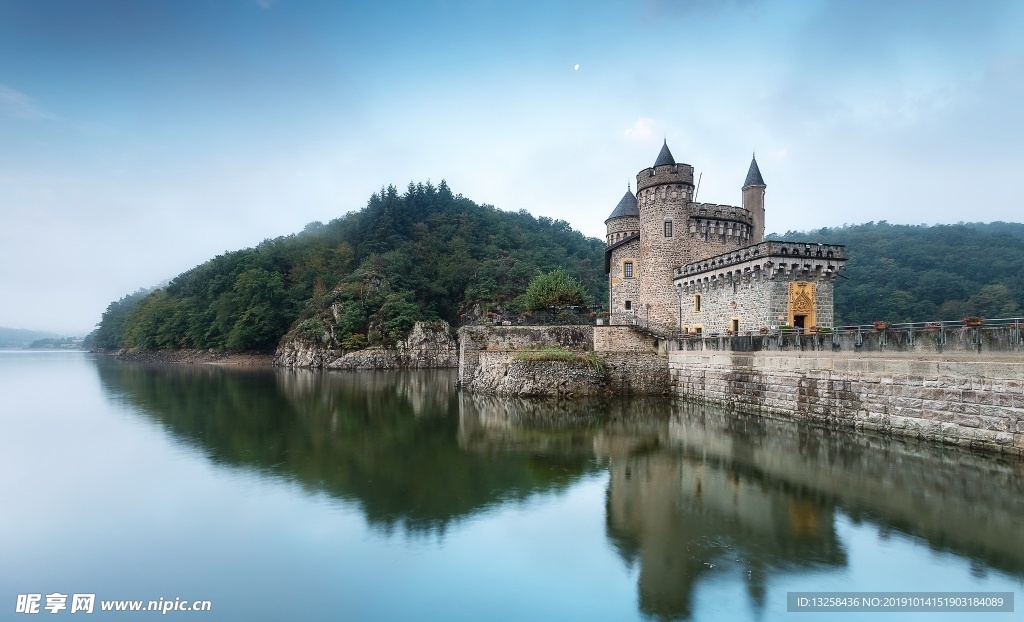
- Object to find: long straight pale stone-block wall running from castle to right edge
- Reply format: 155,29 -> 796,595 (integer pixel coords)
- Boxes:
669,337 -> 1024,455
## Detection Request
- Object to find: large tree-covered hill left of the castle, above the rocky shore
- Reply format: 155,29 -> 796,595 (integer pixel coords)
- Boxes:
95,181 -> 607,350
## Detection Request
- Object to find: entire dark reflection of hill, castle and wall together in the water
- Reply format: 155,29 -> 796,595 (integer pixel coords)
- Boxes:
98,363 -> 1024,619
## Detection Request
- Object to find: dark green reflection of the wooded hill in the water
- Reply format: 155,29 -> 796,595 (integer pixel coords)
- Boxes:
98,362 -> 595,533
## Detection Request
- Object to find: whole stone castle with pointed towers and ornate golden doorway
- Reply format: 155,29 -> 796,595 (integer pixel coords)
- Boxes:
604,141 -> 846,337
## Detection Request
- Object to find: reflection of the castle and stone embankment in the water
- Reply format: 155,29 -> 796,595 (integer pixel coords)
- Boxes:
460,396 -> 1024,619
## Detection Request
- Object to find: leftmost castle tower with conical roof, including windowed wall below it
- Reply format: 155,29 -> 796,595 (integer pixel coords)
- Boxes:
604,189 -> 640,322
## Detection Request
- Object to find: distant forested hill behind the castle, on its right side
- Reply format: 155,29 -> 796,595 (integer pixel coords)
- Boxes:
772,221 -> 1024,325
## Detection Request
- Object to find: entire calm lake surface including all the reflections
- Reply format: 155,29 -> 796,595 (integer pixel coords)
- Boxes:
0,351 -> 1024,621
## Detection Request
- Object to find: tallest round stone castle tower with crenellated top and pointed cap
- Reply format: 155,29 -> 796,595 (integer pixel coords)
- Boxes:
636,141 -> 698,327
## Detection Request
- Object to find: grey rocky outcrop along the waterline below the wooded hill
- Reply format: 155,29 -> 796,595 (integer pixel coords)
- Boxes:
273,322 -> 459,370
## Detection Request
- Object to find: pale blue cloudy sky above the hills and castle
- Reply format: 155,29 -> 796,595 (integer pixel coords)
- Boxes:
0,0 -> 1024,335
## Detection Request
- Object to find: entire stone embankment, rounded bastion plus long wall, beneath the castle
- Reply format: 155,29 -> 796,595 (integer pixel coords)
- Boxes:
459,326 -> 1024,456
